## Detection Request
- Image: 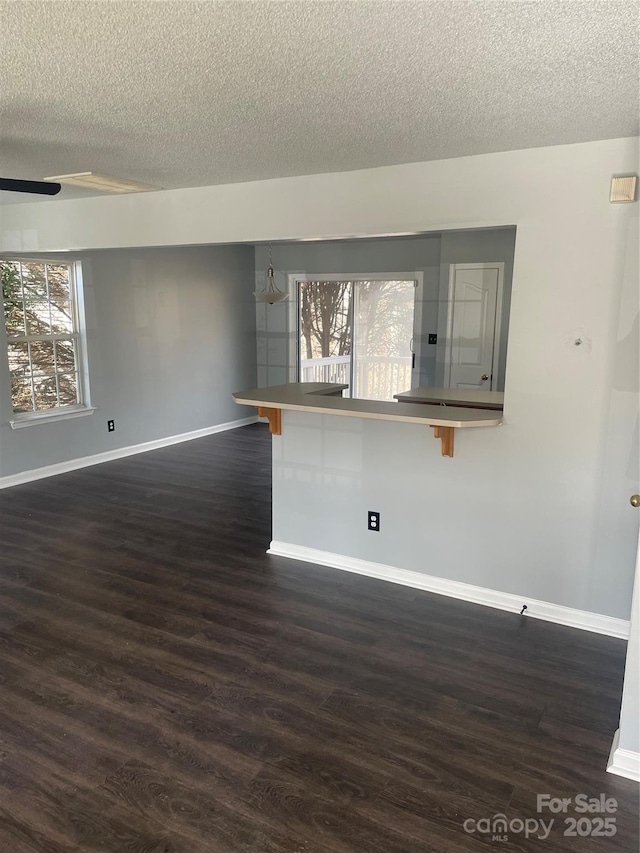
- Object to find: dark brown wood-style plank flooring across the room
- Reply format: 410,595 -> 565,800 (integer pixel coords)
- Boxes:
0,425 -> 638,853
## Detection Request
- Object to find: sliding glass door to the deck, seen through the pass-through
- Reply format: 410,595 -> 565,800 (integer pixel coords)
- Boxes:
298,280 -> 416,400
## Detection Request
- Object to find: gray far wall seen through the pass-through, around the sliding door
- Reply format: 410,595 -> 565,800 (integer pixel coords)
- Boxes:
256,233 -> 515,389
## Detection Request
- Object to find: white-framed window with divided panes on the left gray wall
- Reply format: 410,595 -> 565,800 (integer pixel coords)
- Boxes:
0,259 -> 87,420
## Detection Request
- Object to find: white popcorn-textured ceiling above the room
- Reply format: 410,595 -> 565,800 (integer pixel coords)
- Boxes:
0,0 -> 639,201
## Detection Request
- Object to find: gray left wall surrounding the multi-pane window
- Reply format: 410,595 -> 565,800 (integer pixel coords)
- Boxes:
0,246 -> 256,476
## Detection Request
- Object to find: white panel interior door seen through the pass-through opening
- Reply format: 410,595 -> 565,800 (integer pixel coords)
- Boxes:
445,264 -> 503,391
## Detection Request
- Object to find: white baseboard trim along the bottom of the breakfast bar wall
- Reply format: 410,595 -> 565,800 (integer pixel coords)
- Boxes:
267,540 -> 629,640
